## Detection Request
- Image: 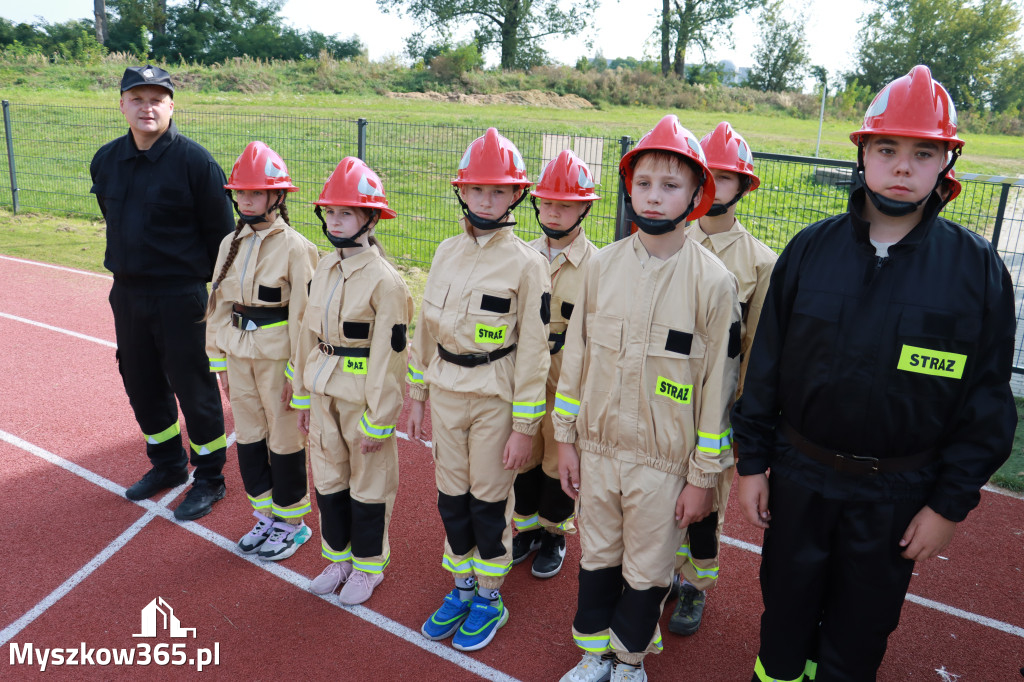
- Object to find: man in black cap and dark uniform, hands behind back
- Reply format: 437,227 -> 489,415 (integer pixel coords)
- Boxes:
89,65 -> 232,520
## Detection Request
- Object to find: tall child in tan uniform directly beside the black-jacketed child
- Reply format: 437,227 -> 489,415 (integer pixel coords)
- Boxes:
554,116 -> 739,682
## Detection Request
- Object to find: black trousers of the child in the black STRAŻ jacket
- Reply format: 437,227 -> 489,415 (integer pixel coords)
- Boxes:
754,473 -> 924,682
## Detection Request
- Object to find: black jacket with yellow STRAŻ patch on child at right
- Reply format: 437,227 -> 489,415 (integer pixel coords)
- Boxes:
732,189 -> 1017,521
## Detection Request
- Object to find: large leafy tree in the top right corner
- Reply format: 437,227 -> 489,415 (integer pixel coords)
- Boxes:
850,0 -> 1021,110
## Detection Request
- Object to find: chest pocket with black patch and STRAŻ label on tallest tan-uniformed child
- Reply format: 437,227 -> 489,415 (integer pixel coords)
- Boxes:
644,323 -> 707,406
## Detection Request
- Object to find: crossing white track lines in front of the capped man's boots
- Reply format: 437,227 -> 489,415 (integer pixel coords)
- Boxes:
0,430 -> 517,682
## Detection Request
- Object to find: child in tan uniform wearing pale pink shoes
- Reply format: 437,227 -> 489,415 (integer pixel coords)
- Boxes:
293,157 -> 413,605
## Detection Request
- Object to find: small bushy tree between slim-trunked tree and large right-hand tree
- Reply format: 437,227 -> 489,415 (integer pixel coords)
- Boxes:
746,0 -> 811,92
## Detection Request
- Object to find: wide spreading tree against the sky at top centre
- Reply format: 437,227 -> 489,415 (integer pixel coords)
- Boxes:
377,0 -> 599,69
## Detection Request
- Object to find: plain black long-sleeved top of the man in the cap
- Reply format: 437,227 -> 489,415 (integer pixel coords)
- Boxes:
89,120 -> 234,293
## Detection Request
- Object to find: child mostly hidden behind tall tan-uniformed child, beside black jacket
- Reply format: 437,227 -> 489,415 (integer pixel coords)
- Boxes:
669,121 -> 777,635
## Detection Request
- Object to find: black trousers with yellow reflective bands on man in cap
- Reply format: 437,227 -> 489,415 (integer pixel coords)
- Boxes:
110,280 -> 226,483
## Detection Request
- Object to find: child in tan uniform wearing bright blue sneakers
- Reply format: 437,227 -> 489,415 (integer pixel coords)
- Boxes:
408,128 -> 551,651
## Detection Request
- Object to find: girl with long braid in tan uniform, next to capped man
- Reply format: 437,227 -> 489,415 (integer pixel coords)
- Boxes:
206,141 -> 318,561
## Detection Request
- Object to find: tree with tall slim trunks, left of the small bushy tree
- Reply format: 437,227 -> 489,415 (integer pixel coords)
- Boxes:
667,0 -> 765,77
